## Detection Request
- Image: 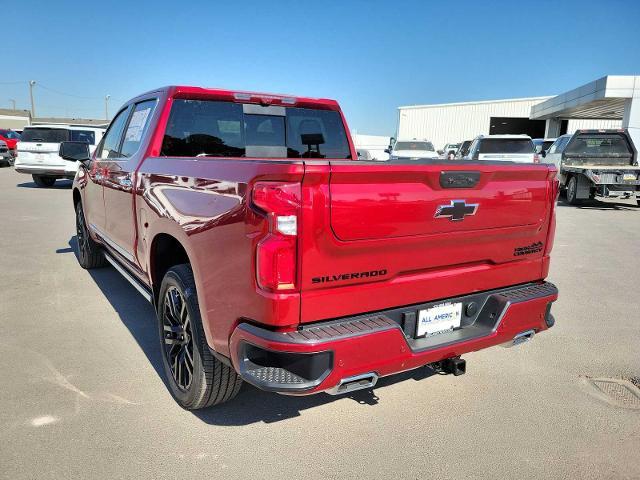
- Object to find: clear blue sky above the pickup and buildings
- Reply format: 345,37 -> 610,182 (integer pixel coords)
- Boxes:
5,0 -> 640,135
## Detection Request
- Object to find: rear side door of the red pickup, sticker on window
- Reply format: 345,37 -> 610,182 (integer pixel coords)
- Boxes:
103,99 -> 156,265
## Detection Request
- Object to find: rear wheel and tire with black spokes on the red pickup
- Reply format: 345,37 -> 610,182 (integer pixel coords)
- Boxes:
156,264 -> 242,410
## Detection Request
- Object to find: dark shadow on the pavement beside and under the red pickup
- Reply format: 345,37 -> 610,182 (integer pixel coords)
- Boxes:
56,235 -> 436,426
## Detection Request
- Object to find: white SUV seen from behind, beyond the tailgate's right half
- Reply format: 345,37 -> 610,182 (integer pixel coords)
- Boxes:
465,135 -> 540,163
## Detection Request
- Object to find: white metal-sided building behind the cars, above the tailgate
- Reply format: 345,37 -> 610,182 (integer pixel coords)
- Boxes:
397,77 -> 622,149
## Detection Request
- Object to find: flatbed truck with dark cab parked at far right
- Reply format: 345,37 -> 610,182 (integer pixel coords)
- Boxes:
543,129 -> 640,205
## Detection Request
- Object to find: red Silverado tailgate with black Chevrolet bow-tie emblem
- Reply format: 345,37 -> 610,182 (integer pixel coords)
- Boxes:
300,162 -> 555,322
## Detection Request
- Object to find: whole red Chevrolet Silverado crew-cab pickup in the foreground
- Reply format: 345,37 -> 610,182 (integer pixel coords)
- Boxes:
60,86 -> 558,409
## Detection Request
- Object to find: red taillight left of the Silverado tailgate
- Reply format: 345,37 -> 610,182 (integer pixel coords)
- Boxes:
252,182 -> 301,292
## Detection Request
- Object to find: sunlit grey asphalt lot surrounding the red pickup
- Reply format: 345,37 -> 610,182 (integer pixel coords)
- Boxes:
0,168 -> 640,479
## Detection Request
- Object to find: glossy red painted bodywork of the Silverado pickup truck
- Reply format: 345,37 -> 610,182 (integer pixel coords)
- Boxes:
74,87 -> 557,390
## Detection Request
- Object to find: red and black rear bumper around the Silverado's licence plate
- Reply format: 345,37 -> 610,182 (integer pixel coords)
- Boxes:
230,282 -> 558,395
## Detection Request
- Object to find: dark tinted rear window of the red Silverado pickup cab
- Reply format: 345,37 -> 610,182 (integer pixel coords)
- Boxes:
161,99 -> 351,158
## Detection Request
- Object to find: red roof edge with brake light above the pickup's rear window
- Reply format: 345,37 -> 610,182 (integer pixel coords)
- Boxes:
127,85 -> 340,110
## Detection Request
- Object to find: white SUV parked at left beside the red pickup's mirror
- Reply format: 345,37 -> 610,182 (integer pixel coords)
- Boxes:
15,125 -> 105,187
